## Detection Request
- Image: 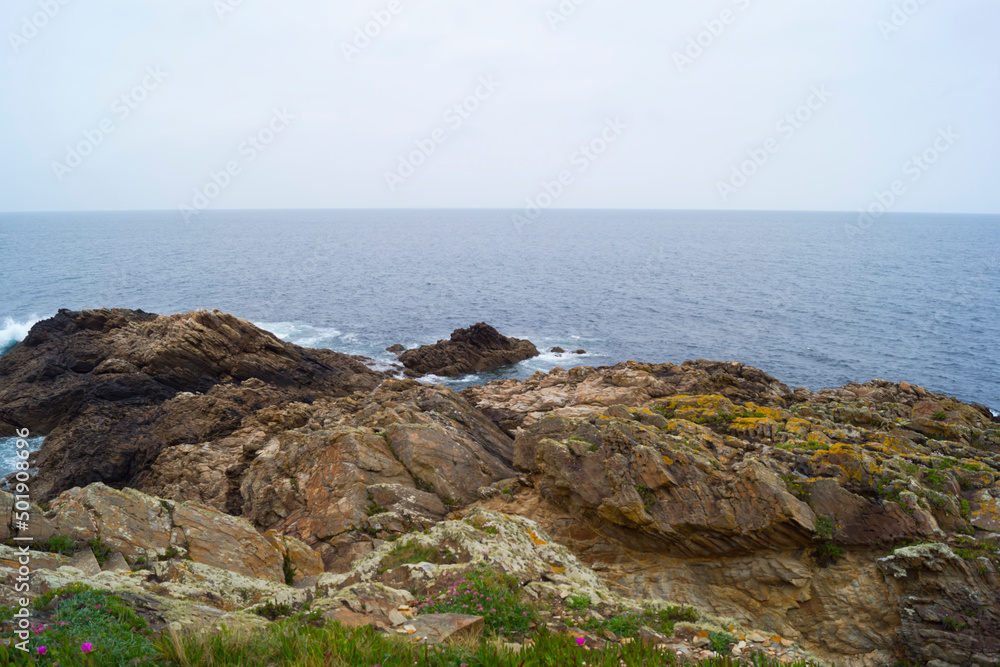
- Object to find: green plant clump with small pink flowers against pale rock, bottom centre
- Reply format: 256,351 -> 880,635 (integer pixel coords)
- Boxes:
416,566 -> 537,637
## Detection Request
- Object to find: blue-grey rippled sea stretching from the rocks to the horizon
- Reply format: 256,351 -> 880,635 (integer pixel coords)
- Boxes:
0,209 -> 1000,473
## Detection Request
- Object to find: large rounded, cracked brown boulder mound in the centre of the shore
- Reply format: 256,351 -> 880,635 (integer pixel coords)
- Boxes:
234,380 -> 516,570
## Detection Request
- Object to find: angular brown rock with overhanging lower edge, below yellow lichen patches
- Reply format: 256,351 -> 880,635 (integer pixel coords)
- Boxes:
514,408 -> 816,556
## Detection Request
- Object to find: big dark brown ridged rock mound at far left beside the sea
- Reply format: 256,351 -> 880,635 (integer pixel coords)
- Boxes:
0,310 -> 382,500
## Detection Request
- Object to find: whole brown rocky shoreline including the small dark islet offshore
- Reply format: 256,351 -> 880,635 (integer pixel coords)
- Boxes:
0,310 -> 1000,667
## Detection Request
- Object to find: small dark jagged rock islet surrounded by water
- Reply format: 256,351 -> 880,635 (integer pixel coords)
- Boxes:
399,322 -> 538,377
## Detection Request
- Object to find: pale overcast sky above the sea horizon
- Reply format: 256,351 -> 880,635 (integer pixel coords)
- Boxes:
0,0 -> 1000,214
